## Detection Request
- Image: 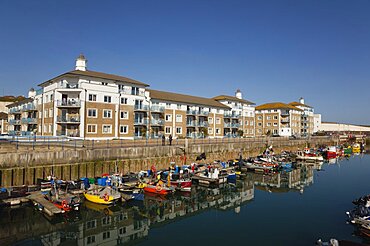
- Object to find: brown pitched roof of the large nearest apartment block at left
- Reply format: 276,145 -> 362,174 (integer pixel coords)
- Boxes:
39,70 -> 149,86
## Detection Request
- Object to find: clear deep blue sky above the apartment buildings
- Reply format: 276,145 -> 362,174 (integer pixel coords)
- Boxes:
0,0 -> 370,124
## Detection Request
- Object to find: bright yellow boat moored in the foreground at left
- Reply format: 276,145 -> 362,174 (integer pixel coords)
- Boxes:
84,187 -> 121,205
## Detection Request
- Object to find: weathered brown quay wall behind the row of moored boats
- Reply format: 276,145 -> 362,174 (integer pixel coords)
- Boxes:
0,138 -> 334,187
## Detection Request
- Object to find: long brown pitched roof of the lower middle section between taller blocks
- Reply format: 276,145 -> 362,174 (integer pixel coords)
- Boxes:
147,89 -> 230,109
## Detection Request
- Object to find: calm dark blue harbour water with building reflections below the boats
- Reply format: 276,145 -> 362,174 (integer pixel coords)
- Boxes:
0,155 -> 370,245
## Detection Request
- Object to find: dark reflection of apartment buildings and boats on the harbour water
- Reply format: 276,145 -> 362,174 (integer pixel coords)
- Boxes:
0,160 -> 350,245
